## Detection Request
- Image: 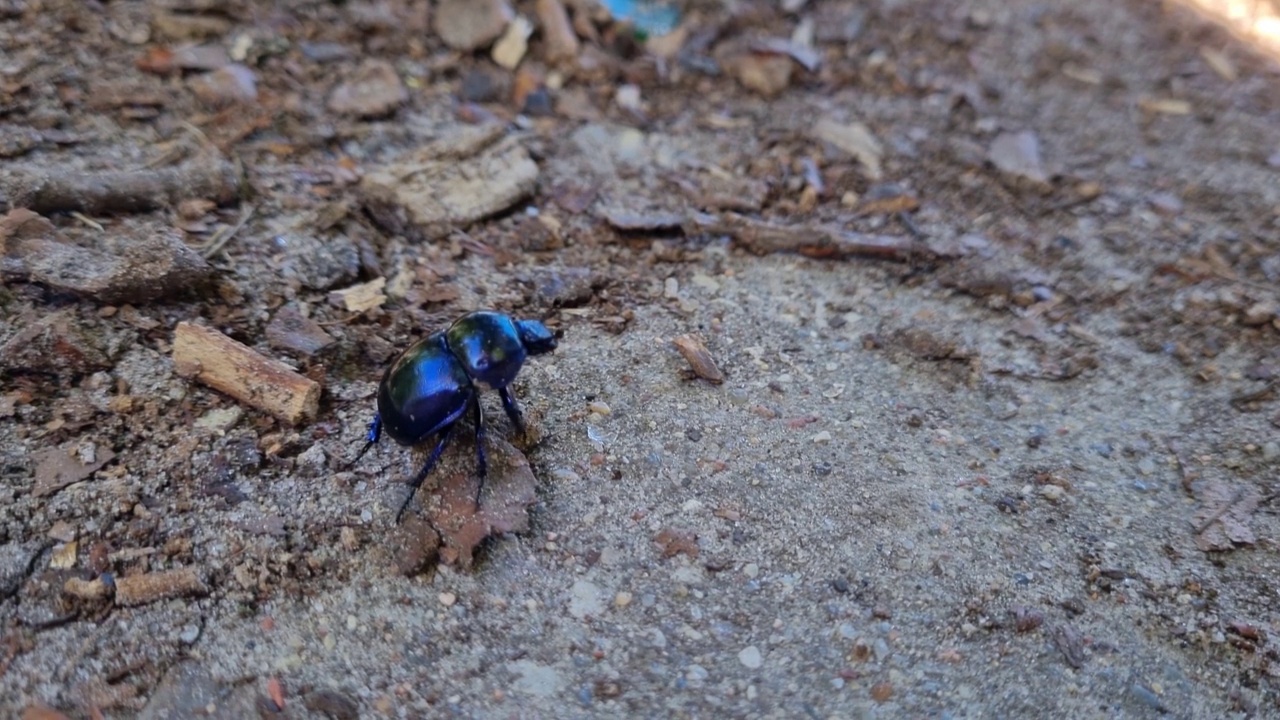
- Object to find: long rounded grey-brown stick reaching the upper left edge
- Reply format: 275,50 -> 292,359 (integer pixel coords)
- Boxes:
0,156 -> 241,215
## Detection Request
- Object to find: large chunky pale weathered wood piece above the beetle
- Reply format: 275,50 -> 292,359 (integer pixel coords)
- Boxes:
360,127 -> 538,242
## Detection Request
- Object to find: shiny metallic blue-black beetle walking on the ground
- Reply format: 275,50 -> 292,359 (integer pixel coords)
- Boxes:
351,310 -> 557,523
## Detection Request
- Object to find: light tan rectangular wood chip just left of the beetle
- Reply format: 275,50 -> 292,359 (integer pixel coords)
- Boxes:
173,317 -> 320,424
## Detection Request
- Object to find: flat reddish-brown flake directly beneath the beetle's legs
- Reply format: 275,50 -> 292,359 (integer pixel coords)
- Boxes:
428,434 -> 538,568
